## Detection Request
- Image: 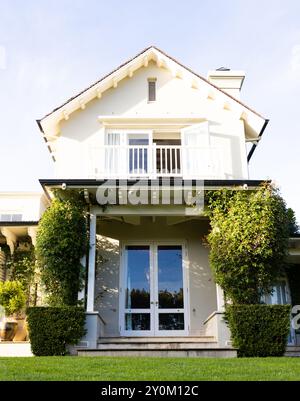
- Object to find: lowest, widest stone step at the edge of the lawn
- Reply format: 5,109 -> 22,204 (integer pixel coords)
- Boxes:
78,348 -> 237,358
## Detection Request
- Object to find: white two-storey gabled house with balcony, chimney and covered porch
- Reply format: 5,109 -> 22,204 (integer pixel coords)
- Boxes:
0,46 -> 300,356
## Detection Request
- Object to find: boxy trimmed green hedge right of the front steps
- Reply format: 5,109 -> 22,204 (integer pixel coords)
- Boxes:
225,305 -> 291,357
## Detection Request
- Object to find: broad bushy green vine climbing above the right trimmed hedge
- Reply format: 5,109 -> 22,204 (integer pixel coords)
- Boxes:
207,184 -> 290,304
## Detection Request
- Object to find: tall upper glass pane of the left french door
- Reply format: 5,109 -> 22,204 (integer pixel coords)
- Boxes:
125,246 -> 150,309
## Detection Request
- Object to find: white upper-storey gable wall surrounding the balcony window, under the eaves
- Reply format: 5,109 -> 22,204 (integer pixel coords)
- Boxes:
55,62 -> 248,179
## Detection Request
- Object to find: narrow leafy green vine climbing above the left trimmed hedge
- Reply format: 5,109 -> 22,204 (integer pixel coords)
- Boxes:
36,190 -> 87,306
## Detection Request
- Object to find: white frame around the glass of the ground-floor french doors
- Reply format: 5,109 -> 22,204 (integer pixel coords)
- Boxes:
119,239 -> 190,337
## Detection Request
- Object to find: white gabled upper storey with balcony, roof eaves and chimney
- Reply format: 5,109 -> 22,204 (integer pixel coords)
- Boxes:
38,47 -> 266,179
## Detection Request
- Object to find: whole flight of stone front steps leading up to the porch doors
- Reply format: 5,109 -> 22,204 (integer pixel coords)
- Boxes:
77,336 -> 236,358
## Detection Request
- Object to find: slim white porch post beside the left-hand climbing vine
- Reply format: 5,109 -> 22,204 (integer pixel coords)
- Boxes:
86,214 -> 97,312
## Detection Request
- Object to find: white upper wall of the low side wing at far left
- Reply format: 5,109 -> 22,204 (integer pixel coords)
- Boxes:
0,192 -> 46,220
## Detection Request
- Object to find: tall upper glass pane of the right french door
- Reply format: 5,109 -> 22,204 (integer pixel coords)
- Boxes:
158,246 -> 183,309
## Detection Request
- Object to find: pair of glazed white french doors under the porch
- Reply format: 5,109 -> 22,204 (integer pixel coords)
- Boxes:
120,242 -> 187,336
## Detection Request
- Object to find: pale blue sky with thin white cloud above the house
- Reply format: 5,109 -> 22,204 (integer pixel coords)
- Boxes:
0,0 -> 300,220
